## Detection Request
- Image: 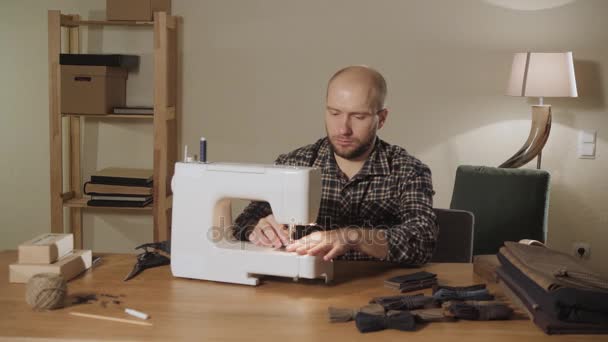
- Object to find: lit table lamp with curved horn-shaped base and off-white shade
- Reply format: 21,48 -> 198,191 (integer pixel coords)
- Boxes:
499,52 -> 578,169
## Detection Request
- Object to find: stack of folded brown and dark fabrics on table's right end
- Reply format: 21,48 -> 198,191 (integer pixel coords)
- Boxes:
496,242 -> 608,334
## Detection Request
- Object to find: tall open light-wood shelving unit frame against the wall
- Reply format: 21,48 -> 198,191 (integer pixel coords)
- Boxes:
48,10 -> 181,248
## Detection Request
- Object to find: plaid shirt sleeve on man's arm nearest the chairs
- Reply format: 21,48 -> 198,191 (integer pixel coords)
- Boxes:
386,163 -> 437,265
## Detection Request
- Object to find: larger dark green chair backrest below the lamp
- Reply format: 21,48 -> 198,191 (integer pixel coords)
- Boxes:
450,165 -> 550,255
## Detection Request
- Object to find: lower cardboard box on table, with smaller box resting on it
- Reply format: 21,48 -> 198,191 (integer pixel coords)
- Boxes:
8,250 -> 93,283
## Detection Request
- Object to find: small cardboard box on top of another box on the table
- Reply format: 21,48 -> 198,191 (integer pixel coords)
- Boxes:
18,233 -> 74,264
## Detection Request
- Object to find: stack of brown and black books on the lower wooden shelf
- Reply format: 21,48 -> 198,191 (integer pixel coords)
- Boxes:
84,167 -> 153,207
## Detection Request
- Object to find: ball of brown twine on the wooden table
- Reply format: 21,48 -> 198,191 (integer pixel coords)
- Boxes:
25,273 -> 68,310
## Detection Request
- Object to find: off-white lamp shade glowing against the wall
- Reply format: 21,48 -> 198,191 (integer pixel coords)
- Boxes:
507,52 -> 578,97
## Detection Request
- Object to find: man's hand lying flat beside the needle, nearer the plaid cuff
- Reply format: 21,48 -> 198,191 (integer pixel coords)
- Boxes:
285,229 -> 361,261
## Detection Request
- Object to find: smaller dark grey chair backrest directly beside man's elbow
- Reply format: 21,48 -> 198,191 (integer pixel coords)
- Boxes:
431,208 -> 474,262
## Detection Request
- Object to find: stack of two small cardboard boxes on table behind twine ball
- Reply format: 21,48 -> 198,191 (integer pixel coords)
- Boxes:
9,234 -> 93,283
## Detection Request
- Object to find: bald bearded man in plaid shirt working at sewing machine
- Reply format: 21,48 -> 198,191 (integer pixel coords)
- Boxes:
234,66 -> 437,265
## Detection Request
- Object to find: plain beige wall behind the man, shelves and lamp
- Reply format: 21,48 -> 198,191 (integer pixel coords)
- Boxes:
0,0 -> 608,274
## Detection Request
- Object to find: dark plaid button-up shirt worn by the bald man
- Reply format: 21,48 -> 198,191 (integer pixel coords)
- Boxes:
234,138 -> 437,264
